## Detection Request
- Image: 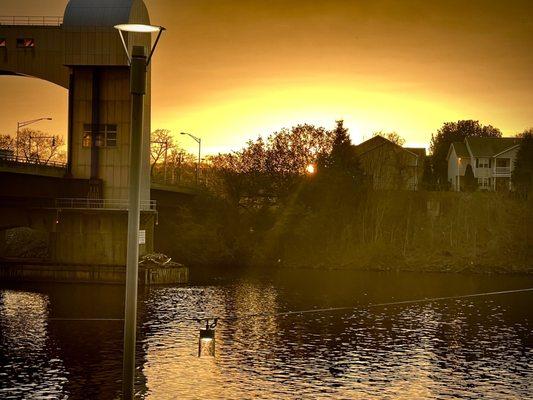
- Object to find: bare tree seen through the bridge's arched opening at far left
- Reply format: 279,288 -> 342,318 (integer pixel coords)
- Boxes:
17,128 -> 66,165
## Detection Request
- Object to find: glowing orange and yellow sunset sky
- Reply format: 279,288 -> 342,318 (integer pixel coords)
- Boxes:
0,0 -> 533,153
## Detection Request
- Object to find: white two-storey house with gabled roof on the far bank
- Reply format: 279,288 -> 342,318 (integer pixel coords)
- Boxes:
447,137 -> 521,191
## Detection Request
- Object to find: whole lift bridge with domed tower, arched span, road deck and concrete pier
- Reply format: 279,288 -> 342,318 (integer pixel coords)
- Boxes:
0,0 -> 190,265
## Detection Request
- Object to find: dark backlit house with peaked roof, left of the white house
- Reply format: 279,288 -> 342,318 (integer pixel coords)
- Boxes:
354,135 -> 426,190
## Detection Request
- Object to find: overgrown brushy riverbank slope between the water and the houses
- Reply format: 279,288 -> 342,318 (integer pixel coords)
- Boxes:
156,191 -> 533,274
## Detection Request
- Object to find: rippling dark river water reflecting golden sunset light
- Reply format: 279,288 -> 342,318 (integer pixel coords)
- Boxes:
0,270 -> 533,399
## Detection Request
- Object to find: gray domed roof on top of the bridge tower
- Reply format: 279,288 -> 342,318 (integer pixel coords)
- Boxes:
63,0 -> 150,27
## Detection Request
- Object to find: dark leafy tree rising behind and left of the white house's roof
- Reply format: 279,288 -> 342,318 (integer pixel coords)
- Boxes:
429,120 -> 502,188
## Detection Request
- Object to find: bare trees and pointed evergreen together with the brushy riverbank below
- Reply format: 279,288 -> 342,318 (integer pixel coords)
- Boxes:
157,121 -> 533,272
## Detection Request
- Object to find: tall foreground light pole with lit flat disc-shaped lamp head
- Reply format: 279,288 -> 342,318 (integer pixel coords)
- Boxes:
115,24 -> 165,399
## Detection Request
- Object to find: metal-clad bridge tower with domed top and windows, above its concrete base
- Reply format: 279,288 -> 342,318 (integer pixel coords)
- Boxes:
0,0 -> 151,202
